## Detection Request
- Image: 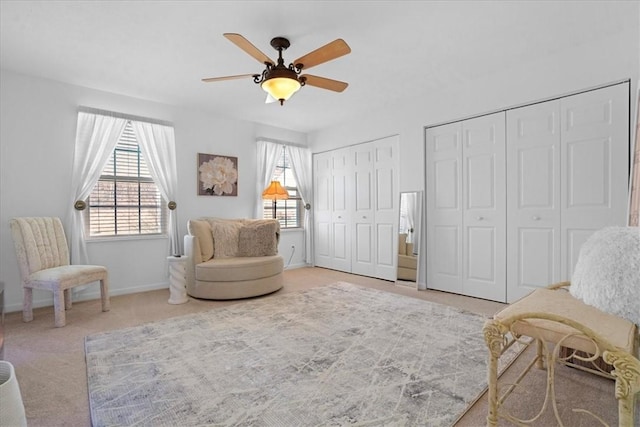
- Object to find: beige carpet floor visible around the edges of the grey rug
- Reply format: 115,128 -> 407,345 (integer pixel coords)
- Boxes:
4,268 -> 628,427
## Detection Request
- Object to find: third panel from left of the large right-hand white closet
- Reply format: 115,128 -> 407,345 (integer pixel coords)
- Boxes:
507,100 -> 560,302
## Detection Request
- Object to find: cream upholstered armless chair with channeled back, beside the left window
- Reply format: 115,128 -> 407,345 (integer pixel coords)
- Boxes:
9,217 -> 109,327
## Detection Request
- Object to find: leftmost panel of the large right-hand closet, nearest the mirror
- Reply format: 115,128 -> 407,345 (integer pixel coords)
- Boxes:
425,122 -> 462,293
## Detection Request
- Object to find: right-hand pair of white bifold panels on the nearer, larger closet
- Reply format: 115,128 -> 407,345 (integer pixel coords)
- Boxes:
507,83 -> 629,302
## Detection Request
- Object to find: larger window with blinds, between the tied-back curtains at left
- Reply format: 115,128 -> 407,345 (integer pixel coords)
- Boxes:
86,121 -> 167,237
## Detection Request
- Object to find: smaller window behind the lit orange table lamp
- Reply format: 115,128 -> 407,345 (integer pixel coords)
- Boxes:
263,146 -> 304,228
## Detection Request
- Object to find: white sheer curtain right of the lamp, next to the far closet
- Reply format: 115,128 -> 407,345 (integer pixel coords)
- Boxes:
286,145 -> 313,264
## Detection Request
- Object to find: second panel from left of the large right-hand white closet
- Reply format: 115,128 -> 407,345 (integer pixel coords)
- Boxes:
462,112 -> 506,302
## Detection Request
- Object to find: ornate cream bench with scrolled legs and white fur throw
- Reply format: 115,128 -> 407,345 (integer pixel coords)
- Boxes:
483,227 -> 640,427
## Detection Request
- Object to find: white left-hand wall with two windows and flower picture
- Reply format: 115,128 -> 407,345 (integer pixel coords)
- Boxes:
0,70 -> 306,312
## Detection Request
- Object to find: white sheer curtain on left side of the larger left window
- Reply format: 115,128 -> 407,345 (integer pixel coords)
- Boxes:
69,111 -> 127,264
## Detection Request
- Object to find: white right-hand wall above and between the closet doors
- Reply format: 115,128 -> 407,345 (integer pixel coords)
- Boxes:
308,21 -> 640,287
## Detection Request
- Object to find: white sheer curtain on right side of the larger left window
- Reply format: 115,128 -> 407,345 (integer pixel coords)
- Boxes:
131,120 -> 182,255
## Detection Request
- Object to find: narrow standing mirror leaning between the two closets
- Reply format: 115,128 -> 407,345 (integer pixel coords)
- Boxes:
397,191 -> 422,286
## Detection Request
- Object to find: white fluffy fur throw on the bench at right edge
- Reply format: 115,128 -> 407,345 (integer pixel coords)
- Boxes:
569,227 -> 640,325
